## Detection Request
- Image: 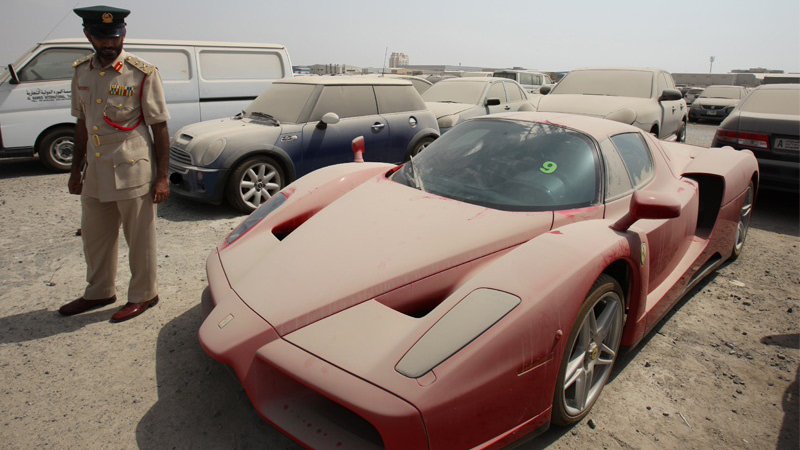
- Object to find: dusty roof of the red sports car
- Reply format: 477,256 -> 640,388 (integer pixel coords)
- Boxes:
471,111 -> 642,140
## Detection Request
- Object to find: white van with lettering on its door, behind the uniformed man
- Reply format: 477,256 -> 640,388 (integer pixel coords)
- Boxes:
0,38 -> 292,170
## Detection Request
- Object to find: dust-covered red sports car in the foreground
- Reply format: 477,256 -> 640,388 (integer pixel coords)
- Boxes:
199,113 -> 759,450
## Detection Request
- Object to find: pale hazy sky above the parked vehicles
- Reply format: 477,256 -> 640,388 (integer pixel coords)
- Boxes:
0,0 -> 800,73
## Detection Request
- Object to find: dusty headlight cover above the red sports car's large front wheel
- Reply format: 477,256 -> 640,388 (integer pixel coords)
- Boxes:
395,288 -> 520,378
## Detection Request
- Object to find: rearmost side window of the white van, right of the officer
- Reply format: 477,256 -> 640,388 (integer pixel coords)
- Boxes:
199,50 -> 284,80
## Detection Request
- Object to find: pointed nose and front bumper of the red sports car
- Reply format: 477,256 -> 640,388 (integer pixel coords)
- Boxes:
199,250 -> 428,449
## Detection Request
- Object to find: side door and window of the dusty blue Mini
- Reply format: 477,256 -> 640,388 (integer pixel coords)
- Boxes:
297,85 -> 390,176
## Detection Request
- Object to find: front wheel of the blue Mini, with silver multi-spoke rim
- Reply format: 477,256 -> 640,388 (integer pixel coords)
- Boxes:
225,155 -> 286,214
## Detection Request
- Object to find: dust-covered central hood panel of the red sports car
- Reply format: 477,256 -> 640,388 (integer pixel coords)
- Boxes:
220,175 -> 553,335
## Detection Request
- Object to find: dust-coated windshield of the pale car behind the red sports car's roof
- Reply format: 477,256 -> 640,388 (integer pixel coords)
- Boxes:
552,70 -> 653,98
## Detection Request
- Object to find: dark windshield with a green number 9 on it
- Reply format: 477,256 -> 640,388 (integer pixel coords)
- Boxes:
392,119 -> 600,211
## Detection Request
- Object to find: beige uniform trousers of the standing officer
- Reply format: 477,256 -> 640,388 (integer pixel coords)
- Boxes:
81,193 -> 158,303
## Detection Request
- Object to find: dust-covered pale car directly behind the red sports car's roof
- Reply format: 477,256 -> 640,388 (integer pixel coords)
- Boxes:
535,68 -> 688,142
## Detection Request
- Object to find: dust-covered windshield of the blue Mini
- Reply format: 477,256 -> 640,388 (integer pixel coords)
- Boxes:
244,83 -> 316,123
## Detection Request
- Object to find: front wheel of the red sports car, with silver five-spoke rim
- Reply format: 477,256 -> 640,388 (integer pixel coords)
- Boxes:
551,274 -> 625,426
